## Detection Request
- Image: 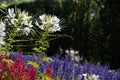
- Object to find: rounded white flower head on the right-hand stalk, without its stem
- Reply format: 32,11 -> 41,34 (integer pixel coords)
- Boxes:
35,14 -> 61,32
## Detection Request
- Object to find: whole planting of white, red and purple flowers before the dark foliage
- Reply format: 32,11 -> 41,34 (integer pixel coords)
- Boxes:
0,8 -> 120,80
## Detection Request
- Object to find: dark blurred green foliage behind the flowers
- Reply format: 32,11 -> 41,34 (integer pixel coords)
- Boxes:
0,0 -> 120,69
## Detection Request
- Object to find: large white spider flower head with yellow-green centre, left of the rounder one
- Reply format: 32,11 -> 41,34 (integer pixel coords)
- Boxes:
4,8 -> 33,36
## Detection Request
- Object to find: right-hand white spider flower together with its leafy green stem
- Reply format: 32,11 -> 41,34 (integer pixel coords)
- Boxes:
33,14 -> 61,54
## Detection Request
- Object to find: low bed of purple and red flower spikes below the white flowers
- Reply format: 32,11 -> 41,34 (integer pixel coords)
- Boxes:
0,54 -> 120,80
